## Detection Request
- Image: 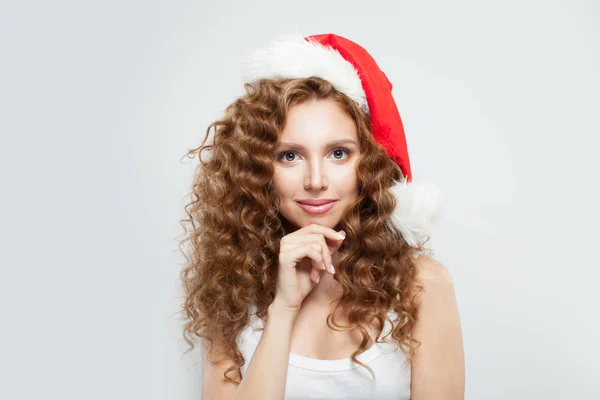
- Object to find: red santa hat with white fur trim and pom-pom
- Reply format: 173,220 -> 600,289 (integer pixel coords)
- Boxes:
240,33 -> 440,246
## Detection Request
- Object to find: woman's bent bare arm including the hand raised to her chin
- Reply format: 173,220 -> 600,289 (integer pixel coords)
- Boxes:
202,224 -> 343,400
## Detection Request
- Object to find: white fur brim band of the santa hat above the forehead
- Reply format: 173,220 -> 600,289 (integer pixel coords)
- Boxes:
244,35 -> 369,113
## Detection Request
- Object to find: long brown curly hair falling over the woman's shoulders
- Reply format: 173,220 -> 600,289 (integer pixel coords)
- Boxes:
179,78 -> 423,385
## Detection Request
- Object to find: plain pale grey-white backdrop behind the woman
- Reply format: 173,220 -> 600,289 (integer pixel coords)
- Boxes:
0,0 -> 600,400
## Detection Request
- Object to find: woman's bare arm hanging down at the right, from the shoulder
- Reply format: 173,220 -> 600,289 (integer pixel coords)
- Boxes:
411,256 -> 465,400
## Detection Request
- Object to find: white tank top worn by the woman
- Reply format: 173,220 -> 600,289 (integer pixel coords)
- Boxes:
237,307 -> 411,400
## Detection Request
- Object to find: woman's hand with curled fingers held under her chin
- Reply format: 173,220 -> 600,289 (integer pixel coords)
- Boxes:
275,224 -> 345,310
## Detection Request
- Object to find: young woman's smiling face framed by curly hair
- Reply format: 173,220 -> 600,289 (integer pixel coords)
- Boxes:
273,100 -> 360,232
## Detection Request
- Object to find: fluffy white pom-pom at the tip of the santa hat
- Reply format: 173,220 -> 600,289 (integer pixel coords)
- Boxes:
389,182 -> 441,247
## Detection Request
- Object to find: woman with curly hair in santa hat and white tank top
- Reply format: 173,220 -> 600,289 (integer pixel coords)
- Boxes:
182,34 -> 464,400
